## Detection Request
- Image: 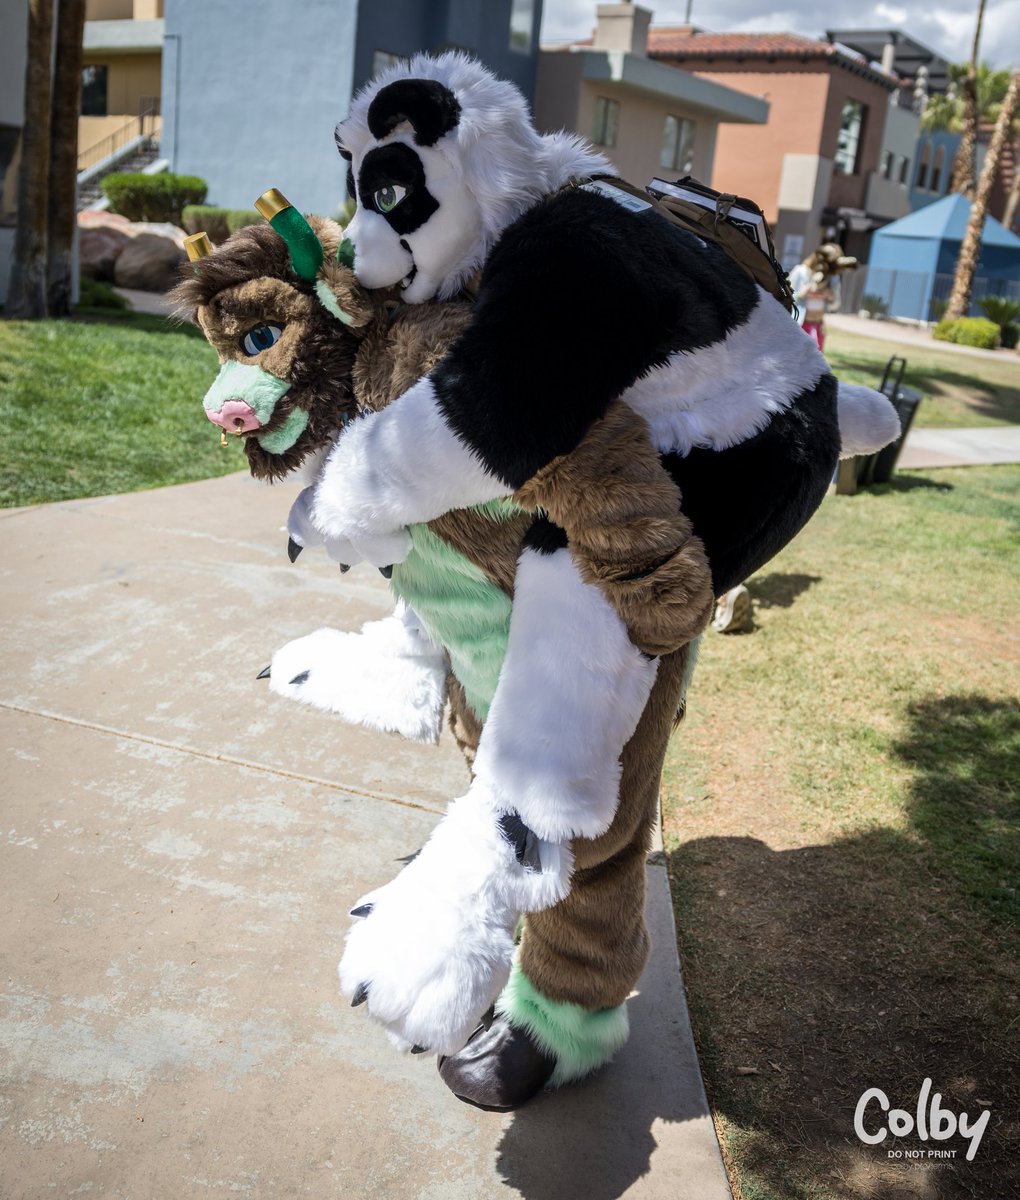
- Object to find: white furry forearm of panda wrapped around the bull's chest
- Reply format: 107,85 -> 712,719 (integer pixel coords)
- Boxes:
312,378 -> 509,542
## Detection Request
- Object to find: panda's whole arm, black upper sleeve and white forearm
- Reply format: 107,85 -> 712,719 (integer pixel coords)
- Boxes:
307,191 -> 739,538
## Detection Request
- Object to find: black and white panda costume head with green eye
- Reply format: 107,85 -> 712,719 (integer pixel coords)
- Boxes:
336,53 -> 611,304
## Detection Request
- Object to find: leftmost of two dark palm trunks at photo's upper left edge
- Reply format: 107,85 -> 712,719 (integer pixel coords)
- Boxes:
6,0 -> 53,318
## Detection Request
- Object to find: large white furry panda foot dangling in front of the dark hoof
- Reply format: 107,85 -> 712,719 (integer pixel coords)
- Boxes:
338,785 -> 572,1054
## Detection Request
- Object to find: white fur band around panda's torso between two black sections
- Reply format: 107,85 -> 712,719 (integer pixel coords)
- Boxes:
622,288 -> 828,454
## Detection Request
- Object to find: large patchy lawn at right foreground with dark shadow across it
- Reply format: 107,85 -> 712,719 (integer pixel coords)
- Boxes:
664,467 -> 1020,1200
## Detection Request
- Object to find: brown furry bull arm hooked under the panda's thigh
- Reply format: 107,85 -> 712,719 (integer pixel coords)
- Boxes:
515,401 -> 714,655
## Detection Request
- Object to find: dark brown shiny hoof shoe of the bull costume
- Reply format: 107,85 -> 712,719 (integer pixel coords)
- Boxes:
438,1016 -> 556,1112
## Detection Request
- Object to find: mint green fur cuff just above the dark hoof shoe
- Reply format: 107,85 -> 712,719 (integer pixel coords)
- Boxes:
496,961 -> 630,1087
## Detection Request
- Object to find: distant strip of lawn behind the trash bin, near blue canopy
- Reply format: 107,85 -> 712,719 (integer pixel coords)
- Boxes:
826,329 -> 1020,428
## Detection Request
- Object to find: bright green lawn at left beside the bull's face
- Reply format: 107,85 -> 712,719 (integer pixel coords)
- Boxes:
0,313 -> 245,506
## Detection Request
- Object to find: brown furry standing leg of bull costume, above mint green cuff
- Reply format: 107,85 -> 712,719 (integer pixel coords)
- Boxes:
521,647 -> 689,1012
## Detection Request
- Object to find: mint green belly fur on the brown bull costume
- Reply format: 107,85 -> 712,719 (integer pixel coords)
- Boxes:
392,511 -> 510,720
